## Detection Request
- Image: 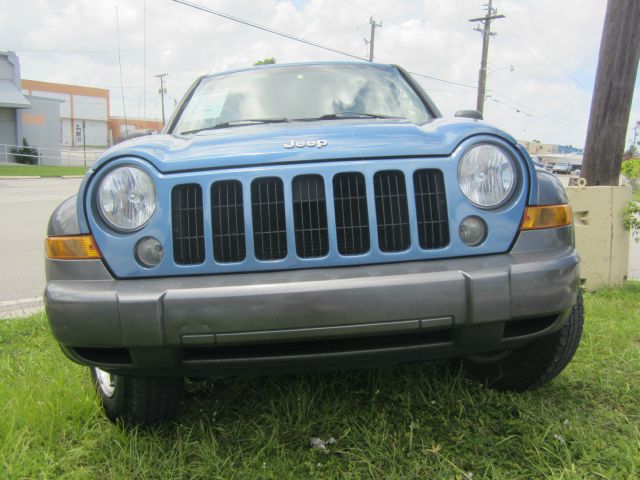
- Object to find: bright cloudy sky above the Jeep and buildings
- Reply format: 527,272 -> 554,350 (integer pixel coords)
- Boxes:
0,0 -> 640,147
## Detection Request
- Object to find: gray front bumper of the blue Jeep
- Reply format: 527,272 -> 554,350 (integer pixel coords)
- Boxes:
45,227 -> 579,374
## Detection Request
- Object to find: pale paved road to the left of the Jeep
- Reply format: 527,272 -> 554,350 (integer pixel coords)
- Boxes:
0,178 -> 81,301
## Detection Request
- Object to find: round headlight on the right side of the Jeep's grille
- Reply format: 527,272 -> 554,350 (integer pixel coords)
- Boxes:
458,144 -> 517,208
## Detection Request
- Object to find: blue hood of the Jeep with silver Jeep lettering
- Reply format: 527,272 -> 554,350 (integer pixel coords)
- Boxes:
94,118 -> 515,173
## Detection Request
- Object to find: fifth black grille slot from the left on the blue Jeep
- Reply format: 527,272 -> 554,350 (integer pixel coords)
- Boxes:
333,172 -> 370,255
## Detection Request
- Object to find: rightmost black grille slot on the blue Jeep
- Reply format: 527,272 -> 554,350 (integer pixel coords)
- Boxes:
413,170 -> 449,250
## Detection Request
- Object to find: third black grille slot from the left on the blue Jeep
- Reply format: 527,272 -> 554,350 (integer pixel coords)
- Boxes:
251,177 -> 287,260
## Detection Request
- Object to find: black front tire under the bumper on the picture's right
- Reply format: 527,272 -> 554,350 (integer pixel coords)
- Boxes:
462,292 -> 584,392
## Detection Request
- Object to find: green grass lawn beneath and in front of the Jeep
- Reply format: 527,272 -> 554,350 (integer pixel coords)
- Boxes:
0,283 -> 640,480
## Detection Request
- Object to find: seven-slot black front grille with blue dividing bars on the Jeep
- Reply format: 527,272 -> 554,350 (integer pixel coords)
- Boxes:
171,169 -> 450,272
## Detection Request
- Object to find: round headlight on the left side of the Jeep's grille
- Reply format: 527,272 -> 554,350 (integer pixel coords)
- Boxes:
98,166 -> 156,232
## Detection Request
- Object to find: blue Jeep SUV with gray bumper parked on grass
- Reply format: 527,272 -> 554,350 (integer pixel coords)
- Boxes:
45,62 -> 583,424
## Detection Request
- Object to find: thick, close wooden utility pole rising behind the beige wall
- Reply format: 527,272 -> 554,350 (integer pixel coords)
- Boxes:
582,0 -> 640,185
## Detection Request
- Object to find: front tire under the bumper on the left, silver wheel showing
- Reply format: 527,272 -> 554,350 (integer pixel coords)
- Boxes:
89,367 -> 183,425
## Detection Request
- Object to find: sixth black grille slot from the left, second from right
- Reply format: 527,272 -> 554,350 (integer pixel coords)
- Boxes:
373,170 -> 411,252
